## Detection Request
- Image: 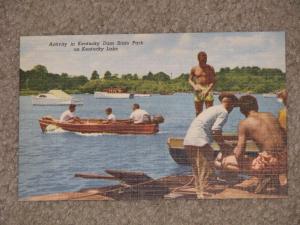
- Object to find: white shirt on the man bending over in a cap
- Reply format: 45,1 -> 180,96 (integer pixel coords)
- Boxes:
183,105 -> 228,147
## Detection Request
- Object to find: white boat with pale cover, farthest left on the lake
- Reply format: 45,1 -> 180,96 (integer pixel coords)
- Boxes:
31,90 -> 83,106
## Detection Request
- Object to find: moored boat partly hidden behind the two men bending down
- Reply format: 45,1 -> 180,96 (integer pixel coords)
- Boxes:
167,133 -> 259,165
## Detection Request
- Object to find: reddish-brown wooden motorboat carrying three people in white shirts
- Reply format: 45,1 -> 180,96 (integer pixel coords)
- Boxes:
39,117 -> 159,134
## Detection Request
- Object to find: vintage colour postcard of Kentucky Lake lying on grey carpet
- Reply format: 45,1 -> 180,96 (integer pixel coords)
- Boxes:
18,32 -> 288,201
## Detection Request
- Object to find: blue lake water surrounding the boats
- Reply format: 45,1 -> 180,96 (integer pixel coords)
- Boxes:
19,94 -> 282,197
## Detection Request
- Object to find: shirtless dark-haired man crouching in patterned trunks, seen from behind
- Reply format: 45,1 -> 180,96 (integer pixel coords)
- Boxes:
215,95 -> 287,193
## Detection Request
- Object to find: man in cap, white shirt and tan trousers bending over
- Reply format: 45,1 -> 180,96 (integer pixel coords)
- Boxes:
183,93 -> 238,198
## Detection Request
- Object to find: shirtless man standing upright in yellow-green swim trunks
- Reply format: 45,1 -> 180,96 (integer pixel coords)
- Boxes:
189,52 -> 216,116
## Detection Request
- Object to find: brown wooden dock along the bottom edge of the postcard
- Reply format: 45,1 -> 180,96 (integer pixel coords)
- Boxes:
21,170 -> 287,201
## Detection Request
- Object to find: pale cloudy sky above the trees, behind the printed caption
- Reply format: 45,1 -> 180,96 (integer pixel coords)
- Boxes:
20,32 -> 286,78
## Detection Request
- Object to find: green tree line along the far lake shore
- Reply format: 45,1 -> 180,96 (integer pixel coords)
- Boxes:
20,65 -> 285,94
